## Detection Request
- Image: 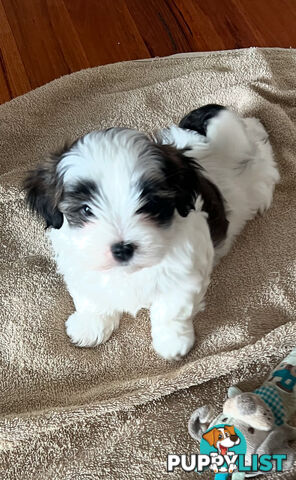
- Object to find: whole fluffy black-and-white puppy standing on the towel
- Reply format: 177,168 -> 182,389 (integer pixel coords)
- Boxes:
25,105 -> 279,360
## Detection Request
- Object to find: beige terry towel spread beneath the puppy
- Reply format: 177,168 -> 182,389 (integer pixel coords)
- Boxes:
0,49 -> 296,480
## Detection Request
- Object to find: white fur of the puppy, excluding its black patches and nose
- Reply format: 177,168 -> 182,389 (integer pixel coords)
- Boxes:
49,110 -> 279,360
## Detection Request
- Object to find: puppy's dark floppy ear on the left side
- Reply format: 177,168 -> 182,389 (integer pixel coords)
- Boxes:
23,154 -> 63,228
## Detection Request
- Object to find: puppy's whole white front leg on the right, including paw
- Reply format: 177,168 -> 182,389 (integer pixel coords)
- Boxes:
150,292 -> 195,360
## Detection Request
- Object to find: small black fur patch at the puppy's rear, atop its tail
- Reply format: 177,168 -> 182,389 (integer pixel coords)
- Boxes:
179,103 -> 226,137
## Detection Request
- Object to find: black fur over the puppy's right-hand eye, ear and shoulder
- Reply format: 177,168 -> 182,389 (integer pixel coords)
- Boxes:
137,145 -> 228,245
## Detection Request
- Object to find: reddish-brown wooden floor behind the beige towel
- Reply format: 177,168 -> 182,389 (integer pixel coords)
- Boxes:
0,0 -> 296,103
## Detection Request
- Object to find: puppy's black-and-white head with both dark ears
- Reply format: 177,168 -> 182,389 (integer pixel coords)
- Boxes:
24,128 -> 200,270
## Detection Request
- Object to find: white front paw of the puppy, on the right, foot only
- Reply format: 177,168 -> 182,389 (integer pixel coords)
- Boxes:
153,327 -> 194,360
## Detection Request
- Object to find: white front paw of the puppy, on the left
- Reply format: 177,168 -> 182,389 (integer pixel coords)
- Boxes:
66,312 -> 120,347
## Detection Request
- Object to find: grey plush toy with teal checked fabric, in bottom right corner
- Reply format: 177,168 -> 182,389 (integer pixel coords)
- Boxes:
189,348 -> 296,480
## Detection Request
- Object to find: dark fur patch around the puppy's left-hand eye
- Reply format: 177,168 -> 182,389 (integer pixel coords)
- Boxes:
60,180 -> 99,227
